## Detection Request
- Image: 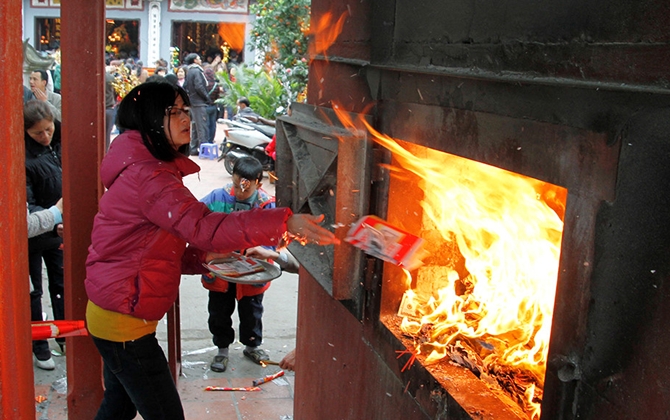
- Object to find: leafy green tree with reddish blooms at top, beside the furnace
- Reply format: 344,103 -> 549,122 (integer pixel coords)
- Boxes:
249,0 -> 311,101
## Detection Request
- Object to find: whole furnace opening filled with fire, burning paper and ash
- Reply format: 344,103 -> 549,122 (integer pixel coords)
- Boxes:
382,142 -> 567,418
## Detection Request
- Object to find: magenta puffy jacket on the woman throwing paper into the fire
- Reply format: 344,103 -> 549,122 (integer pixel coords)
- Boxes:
85,131 -> 291,320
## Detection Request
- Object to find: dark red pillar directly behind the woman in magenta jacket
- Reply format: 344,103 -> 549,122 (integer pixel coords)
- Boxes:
61,0 -> 105,419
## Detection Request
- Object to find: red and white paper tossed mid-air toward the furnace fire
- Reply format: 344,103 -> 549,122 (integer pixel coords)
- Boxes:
344,216 -> 423,270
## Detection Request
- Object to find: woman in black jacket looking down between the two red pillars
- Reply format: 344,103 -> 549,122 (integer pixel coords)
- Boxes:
23,100 -> 65,370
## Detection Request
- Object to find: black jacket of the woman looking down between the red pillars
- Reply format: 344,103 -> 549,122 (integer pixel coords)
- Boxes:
25,121 -> 63,249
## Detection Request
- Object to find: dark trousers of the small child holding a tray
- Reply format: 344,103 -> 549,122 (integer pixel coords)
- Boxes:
207,283 -> 263,348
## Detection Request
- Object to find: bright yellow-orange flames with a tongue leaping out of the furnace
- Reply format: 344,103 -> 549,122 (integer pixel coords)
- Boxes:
333,105 -> 567,418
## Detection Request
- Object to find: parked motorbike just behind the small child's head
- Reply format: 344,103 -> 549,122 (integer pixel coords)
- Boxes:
219,118 -> 275,175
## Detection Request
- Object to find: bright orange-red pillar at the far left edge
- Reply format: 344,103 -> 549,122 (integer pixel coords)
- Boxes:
0,0 -> 35,419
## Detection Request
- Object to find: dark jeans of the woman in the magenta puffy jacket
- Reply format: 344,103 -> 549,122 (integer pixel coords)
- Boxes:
92,333 -> 184,420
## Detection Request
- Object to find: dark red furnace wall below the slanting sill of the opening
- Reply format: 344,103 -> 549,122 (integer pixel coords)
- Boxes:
293,269 -> 440,420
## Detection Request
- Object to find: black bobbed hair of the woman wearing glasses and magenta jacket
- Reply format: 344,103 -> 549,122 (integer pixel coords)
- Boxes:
116,82 -> 191,161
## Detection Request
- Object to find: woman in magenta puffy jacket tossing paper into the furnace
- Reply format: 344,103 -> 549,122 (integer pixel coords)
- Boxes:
85,83 -> 339,420
